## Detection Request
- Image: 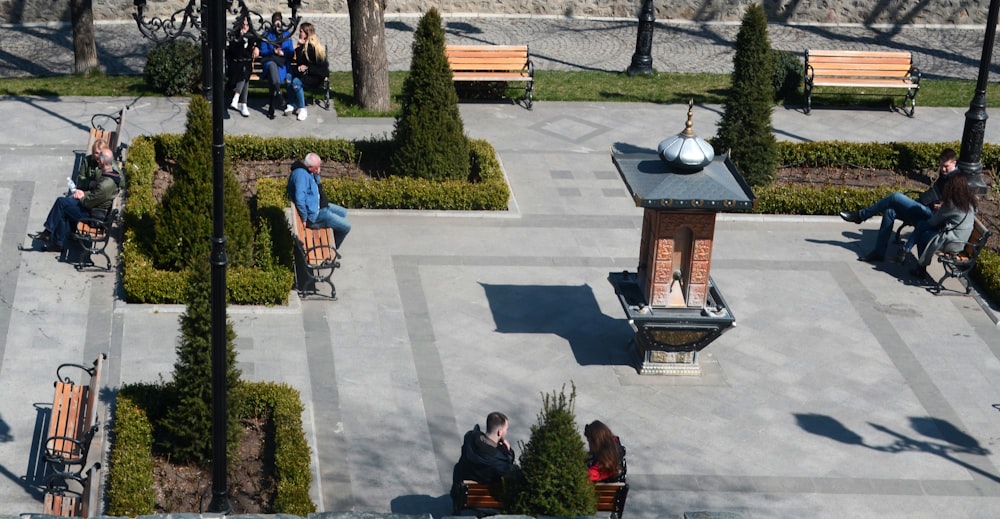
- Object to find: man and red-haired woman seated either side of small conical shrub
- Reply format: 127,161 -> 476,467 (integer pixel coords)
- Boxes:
451,411 -> 625,508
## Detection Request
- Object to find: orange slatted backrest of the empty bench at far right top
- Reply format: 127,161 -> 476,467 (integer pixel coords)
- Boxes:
805,49 -> 913,79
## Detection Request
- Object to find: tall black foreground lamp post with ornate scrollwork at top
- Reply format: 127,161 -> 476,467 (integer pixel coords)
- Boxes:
133,0 -> 302,514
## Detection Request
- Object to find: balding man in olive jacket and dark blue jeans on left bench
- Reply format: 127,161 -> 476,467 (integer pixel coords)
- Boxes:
28,148 -> 121,252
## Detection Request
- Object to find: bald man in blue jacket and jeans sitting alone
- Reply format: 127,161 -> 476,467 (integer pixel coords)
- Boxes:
288,153 -> 351,249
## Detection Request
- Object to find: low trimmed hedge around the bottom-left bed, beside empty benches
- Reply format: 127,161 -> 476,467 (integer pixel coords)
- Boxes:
107,382 -> 316,517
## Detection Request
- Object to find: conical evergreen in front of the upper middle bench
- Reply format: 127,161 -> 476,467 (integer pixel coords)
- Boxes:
390,8 -> 469,181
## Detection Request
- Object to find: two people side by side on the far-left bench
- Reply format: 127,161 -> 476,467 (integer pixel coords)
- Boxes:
28,139 -> 121,252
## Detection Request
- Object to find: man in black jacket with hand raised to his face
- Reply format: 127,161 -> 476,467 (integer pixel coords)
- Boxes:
451,412 -> 517,499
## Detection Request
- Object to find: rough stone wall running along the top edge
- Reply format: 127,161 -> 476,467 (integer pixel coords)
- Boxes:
0,0 -> 989,25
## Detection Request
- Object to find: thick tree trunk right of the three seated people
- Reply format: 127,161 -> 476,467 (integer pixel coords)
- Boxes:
347,0 -> 389,111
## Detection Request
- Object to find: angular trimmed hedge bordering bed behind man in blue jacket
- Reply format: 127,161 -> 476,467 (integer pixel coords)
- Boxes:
121,134 -> 510,305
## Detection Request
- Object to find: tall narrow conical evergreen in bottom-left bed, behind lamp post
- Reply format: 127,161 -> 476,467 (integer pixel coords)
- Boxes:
159,254 -> 241,464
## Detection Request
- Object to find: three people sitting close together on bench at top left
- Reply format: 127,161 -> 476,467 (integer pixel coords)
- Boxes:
227,13 -> 330,121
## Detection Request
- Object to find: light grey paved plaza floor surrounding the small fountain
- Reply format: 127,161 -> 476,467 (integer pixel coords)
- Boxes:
0,14 -> 1000,519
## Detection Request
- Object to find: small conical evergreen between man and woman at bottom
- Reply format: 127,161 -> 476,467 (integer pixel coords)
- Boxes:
505,385 -> 597,517
